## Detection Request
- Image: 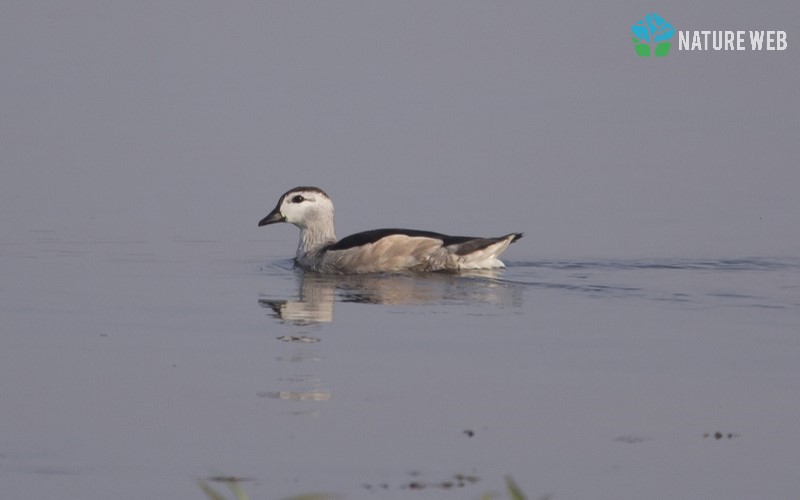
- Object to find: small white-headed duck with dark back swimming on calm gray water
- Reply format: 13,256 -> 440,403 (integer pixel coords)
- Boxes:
258,187 -> 522,274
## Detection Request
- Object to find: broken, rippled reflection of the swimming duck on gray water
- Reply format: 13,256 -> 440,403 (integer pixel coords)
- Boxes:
258,268 -> 523,408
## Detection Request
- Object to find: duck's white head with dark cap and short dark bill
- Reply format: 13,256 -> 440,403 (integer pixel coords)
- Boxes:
258,187 -> 333,233
